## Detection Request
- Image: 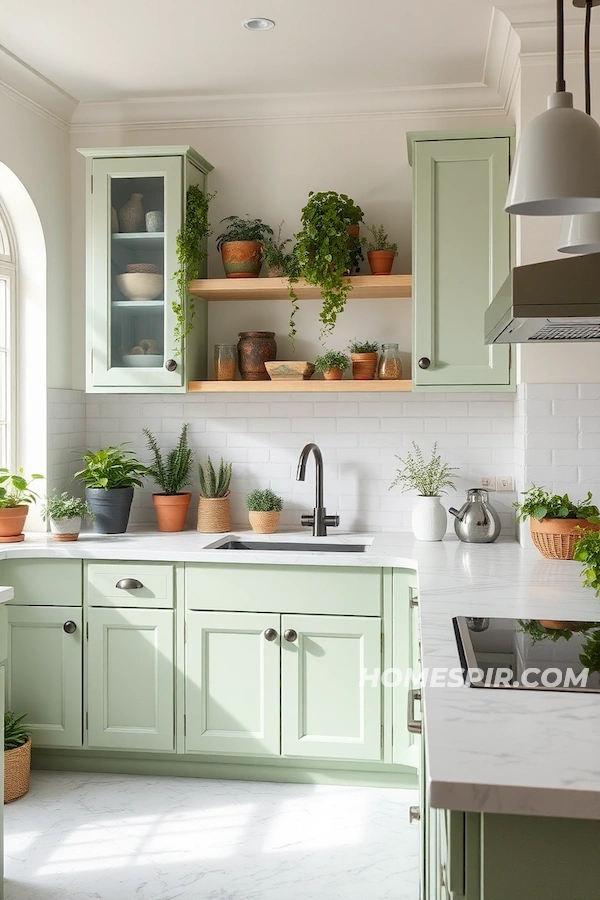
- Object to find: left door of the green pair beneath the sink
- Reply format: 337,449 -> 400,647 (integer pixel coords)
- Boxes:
186,612 -> 280,756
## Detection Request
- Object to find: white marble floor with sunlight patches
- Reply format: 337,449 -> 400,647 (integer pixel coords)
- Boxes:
5,772 -> 419,900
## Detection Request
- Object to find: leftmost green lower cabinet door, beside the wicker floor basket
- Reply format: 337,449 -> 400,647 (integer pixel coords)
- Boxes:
6,606 -> 83,747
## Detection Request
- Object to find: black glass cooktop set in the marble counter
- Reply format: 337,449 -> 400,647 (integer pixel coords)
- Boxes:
452,616 -> 600,693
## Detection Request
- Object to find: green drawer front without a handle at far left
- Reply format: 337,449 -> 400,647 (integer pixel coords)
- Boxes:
0,559 -> 83,606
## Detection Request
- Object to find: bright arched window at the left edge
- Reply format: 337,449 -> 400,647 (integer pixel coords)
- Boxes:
0,203 -> 17,468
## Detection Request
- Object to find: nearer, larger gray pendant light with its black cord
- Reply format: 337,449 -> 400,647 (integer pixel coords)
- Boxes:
505,0 -> 600,216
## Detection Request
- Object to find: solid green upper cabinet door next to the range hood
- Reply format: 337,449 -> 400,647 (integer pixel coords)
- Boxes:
413,137 -> 510,389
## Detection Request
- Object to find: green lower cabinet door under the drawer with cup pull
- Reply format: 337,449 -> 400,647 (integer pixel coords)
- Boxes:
87,609 -> 175,750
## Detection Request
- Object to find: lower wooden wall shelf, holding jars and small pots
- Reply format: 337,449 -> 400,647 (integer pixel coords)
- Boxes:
188,378 -> 412,394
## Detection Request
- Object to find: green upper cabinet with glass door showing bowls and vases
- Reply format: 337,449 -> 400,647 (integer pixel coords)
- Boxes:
79,147 -> 212,393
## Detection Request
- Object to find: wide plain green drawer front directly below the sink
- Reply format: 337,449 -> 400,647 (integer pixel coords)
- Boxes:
185,563 -> 382,616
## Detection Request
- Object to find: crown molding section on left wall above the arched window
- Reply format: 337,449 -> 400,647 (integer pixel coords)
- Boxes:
0,46 -> 77,132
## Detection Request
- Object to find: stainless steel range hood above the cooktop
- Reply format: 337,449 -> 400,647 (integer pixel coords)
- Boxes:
485,253 -> 600,344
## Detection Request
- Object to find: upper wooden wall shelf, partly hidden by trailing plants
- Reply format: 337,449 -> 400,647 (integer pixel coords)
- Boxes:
190,275 -> 412,301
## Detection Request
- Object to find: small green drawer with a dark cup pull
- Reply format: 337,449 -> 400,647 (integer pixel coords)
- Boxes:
87,562 -> 175,609
